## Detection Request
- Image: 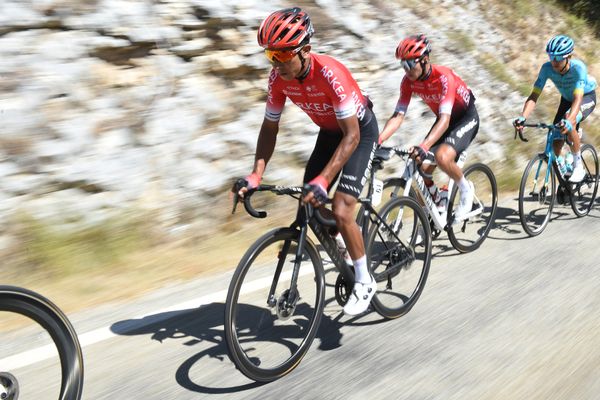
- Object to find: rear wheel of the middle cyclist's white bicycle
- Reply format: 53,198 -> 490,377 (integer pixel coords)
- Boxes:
448,163 -> 498,253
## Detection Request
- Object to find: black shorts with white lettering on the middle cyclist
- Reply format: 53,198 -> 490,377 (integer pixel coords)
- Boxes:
428,93 -> 479,160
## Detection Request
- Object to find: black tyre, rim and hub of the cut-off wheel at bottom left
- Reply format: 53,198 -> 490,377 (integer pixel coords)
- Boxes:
0,286 -> 83,400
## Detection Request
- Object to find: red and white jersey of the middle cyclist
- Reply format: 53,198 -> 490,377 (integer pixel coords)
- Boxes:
396,65 -> 471,117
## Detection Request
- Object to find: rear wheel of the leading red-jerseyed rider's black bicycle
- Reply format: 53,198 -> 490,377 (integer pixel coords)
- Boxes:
366,196 -> 432,318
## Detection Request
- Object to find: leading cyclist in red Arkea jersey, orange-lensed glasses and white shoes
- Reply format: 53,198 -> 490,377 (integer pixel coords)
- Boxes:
238,7 -> 379,315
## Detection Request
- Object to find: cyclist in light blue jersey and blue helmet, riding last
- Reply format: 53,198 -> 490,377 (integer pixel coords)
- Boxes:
513,35 -> 597,182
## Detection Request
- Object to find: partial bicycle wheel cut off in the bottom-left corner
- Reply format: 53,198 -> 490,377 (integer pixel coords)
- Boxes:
0,286 -> 83,400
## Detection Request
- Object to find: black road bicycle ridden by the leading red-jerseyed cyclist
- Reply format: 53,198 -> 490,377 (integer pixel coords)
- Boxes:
224,164 -> 431,382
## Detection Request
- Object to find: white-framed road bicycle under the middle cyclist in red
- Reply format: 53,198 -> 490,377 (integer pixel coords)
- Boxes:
378,146 -> 498,253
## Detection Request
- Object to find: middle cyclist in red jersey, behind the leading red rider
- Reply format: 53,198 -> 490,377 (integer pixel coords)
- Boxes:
379,35 -> 479,221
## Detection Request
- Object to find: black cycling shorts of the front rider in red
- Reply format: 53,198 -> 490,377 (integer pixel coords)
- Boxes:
304,109 -> 379,198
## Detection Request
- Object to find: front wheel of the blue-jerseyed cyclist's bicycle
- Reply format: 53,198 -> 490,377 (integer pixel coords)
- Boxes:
519,154 -> 556,236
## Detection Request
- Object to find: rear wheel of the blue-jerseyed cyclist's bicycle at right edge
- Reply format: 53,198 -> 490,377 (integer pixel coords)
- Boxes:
570,143 -> 598,217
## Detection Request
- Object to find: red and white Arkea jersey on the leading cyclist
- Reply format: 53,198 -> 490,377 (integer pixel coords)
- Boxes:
265,54 -> 367,131
